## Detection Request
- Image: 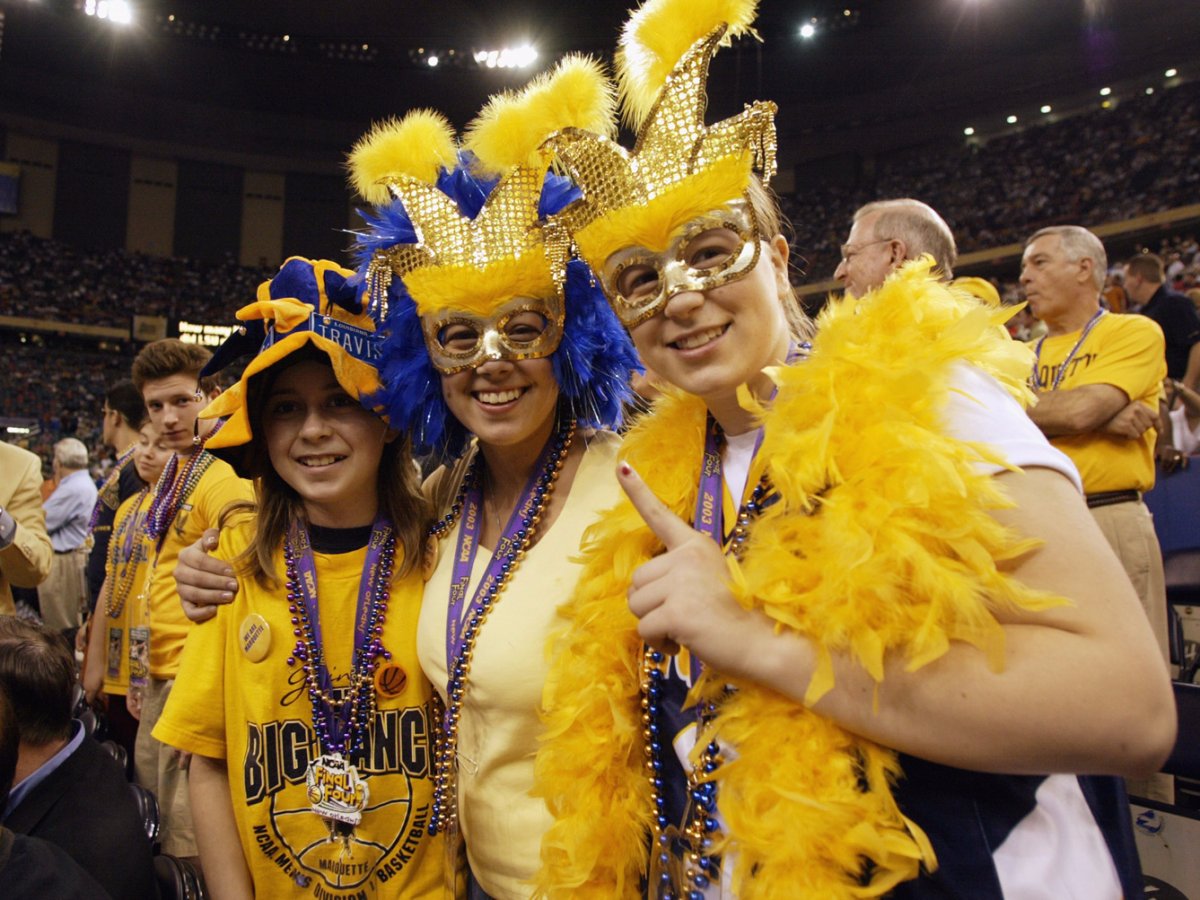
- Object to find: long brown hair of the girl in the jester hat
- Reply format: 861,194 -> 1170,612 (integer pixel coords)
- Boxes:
220,350 -> 433,588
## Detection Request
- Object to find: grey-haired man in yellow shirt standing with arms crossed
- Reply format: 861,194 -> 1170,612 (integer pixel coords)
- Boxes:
1021,226 -> 1168,659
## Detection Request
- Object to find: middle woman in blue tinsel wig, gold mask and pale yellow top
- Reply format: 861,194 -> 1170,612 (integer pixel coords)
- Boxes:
176,58 -> 638,898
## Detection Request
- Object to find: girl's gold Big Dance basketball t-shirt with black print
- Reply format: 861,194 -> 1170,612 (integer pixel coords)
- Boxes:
154,524 -> 444,900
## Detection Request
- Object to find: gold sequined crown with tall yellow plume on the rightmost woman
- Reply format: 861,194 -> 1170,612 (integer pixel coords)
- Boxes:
550,0 -> 776,289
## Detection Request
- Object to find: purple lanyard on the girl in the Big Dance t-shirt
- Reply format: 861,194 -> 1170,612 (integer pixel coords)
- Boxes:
288,516 -> 391,744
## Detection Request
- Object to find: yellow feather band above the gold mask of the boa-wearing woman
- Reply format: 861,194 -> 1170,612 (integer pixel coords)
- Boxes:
575,151 -> 752,271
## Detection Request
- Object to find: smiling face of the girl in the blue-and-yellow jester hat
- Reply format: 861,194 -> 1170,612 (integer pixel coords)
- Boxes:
264,360 -> 395,528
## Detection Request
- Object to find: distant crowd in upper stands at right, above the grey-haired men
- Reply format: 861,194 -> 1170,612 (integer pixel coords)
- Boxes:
784,84 -> 1200,281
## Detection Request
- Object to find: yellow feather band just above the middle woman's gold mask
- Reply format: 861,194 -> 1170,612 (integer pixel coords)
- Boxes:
404,254 -> 557,316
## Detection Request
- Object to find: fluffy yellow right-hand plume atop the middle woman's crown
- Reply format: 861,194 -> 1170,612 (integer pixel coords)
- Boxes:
463,54 -> 617,175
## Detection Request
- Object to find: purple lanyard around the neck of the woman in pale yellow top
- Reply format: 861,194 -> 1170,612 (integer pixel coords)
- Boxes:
446,434 -> 554,676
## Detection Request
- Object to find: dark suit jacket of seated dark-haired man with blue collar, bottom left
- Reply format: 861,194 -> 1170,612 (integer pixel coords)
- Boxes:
5,737 -> 158,900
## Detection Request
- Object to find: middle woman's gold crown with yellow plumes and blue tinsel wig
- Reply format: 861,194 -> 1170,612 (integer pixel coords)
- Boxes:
349,56 -> 640,458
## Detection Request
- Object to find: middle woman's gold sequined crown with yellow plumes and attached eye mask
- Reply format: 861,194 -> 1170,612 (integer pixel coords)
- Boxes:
349,55 -> 614,372
